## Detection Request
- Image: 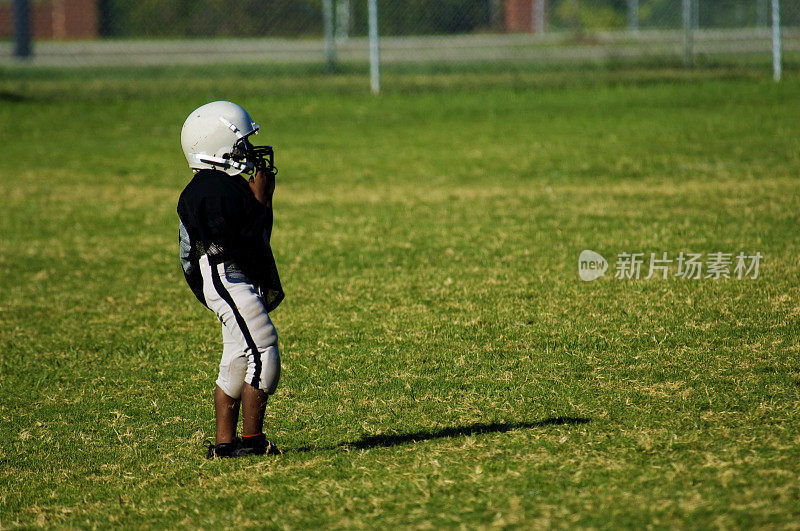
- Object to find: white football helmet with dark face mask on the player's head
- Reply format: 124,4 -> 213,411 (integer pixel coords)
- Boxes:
181,101 -> 260,179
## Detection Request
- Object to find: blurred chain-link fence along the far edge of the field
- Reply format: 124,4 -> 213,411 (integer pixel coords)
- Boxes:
0,0 -> 800,88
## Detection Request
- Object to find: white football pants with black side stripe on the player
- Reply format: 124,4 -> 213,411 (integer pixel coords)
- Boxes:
200,255 -> 281,399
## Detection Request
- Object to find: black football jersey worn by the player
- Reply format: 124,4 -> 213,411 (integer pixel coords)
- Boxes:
178,170 -> 284,312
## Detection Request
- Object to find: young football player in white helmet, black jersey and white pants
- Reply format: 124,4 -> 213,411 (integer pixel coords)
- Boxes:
178,101 -> 284,459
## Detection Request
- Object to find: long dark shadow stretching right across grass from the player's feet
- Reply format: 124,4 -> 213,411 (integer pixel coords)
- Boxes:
289,417 -> 589,452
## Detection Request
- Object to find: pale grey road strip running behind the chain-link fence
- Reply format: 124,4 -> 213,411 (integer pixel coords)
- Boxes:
0,28 -> 800,67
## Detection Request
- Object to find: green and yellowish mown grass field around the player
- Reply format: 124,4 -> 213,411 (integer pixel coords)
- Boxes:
0,70 -> 800,529
